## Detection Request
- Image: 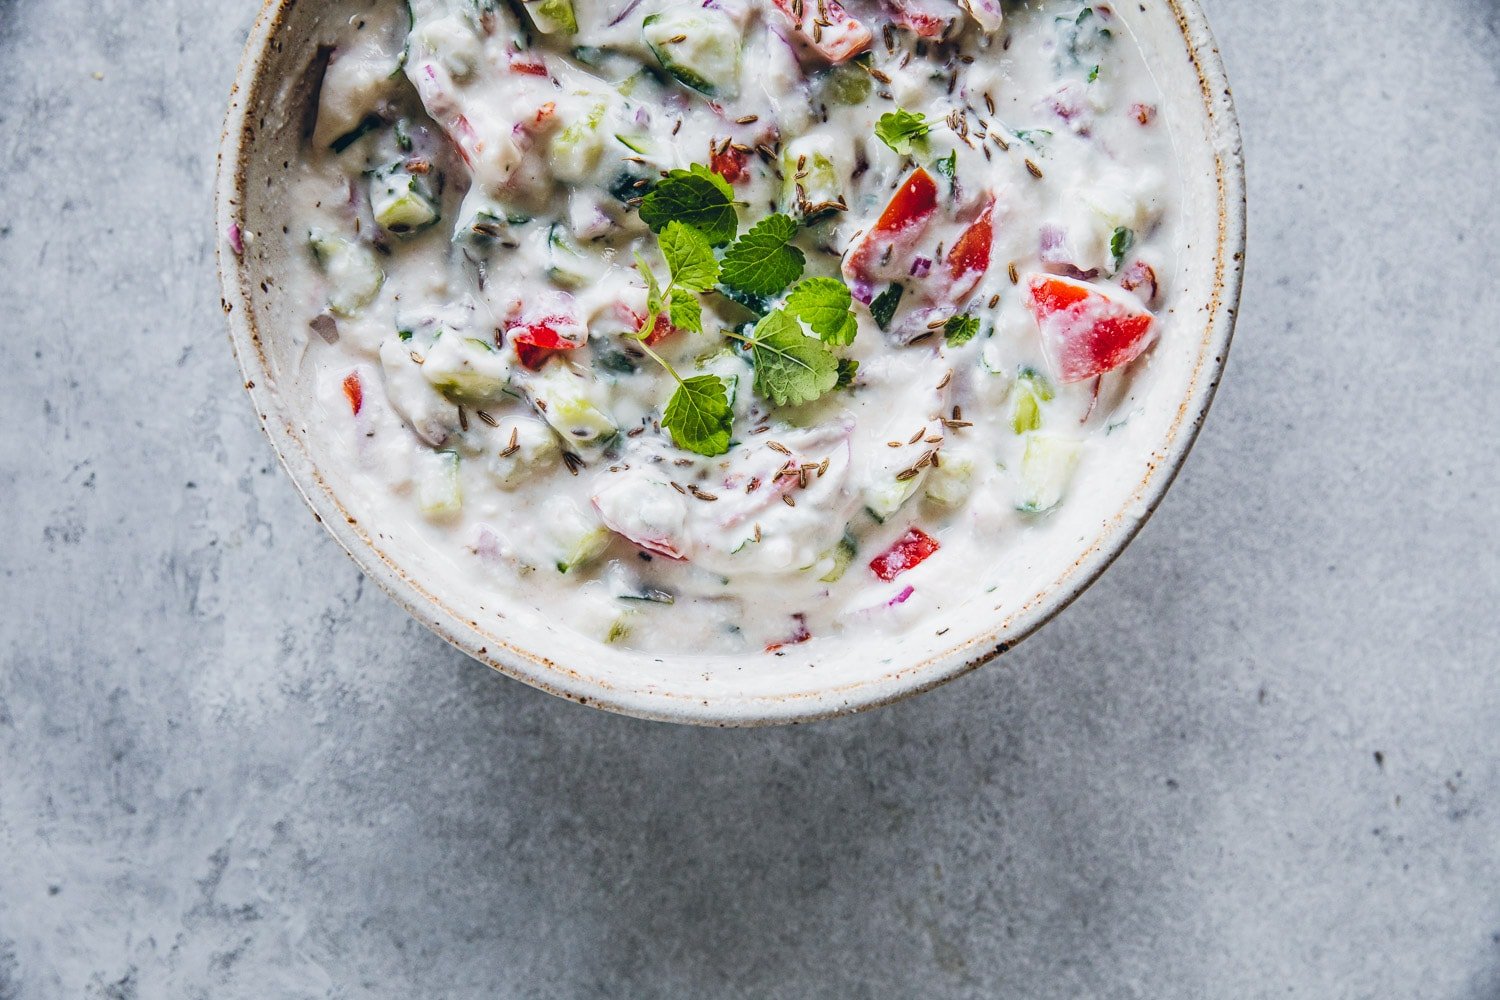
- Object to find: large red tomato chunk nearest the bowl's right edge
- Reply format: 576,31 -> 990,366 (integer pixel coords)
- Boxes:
1026,274 -> 1155,382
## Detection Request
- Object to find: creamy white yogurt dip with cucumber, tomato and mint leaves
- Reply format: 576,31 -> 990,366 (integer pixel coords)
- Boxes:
285,0 -> 1179,654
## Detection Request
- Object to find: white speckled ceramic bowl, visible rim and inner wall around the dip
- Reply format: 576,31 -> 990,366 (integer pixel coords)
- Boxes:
216,0 -> 1245,726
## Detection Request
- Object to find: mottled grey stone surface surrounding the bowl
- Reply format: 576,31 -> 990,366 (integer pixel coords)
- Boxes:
0,0 -> 1500,1000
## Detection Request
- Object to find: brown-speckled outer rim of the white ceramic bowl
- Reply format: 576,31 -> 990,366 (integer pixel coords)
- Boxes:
215,0 -> 1245,726
